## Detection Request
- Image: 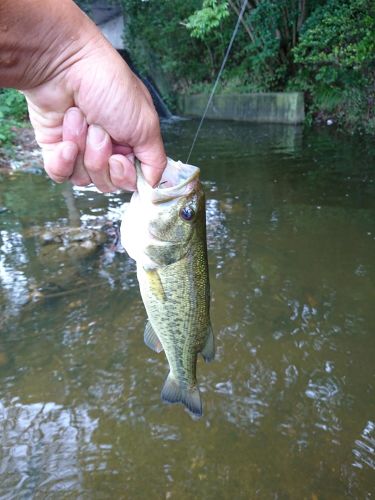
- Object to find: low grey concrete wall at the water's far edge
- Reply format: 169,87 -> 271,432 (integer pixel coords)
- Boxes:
178,92 -> 305,125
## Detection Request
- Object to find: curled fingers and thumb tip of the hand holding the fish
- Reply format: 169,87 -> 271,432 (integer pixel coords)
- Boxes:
43,104 -> 167,192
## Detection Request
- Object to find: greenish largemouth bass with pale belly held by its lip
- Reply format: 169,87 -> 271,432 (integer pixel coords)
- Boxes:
120,158 -> 215,417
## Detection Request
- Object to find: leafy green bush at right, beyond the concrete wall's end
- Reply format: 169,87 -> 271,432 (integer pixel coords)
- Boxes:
290,0 -> 375,131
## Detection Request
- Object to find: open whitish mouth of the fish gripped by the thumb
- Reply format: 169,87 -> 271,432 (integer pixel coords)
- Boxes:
136,158 -> 200,203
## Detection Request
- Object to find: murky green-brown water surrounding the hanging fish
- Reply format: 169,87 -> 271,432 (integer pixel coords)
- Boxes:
0,122 -> 375,500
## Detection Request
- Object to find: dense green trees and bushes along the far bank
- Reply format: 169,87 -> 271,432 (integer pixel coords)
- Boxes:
119,0 -> 375,133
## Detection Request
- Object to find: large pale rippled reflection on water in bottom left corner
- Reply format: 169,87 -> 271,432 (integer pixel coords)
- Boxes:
0,402 -> 98,498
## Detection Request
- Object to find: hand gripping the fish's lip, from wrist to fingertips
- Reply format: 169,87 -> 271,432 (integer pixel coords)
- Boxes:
24,37 -> 166,192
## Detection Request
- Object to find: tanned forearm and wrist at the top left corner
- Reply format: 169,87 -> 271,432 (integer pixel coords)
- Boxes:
0,0 -> 100,90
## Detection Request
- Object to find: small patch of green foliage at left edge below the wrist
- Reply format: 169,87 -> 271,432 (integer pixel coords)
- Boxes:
0,89 -> 27,149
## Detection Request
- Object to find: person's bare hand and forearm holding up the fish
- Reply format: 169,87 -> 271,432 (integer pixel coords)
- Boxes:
0,0 -> 166,192
